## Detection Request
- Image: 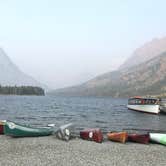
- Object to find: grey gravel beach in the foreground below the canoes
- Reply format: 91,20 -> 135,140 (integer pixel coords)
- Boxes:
0,135 -> 166,166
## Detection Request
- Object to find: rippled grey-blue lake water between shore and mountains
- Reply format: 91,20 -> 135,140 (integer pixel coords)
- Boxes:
0,96 -> 166,131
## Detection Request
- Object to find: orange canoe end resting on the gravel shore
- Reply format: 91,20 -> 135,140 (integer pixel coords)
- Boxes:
107,132 -> 128,143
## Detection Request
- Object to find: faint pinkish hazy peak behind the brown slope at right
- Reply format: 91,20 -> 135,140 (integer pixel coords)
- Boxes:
119,37 -> 166,69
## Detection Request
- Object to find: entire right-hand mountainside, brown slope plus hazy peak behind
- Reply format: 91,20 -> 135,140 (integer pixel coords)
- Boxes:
52,35 -> 166,97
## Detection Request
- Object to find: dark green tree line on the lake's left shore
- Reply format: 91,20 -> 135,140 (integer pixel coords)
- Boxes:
0,85 -> 45,96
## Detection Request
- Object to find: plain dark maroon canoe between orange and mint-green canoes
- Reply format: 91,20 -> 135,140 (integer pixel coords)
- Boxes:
128,134 -> 150,144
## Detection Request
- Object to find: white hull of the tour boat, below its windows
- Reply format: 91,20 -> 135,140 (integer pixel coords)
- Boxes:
127,104 -> 160,114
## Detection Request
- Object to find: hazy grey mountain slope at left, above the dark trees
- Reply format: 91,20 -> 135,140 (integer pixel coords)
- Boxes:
0,48 -> 43,87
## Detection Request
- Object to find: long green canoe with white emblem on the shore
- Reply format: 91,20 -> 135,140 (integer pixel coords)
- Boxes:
4,122 -> 54,137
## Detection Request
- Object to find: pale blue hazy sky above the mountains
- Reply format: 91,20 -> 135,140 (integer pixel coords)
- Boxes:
0,0 -> 166,88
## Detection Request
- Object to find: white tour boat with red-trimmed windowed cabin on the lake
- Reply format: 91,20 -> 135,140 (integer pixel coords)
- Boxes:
127,96 -> 160,114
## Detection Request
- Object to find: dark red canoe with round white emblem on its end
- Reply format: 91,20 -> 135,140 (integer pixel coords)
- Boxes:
80,128 -> 103,143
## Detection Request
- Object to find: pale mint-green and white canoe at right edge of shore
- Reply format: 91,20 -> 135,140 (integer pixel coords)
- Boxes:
149,133 -> 166,145
